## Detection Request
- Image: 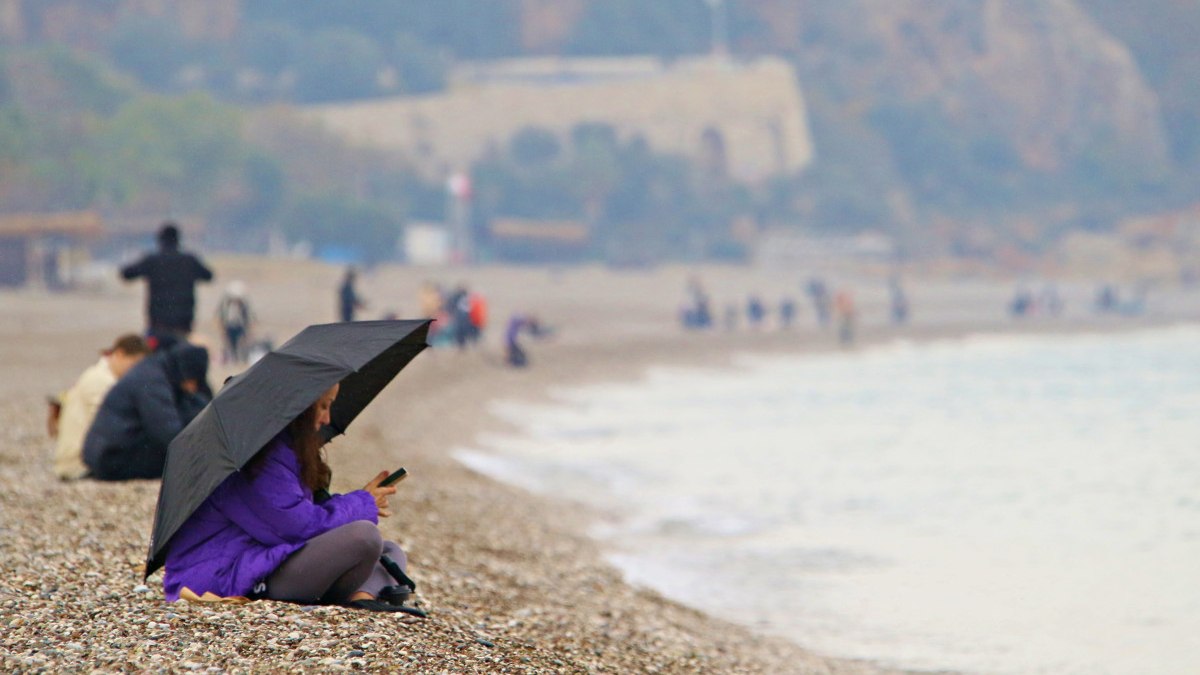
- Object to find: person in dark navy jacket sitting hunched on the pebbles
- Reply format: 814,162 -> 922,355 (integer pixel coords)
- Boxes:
83,342 -> 212,480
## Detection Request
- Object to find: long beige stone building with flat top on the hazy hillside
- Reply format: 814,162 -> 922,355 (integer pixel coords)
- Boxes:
307,58 -> 814,181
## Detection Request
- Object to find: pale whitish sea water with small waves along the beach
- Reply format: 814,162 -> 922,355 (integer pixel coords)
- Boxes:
458,327 -> 1200,674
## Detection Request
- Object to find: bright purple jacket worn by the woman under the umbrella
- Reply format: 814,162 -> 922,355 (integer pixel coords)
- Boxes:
162,434 -> 379,602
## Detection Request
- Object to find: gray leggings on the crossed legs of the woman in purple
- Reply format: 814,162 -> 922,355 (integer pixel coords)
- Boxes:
266,520 -> 408,604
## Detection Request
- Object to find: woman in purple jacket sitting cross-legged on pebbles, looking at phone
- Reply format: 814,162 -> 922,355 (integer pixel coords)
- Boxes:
163,384 -> 410,611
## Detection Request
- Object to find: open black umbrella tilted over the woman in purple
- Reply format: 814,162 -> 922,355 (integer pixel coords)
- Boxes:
145,319 -> 430,577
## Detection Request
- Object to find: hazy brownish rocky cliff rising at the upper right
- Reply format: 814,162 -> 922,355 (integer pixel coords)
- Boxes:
746,0 -> 1166,172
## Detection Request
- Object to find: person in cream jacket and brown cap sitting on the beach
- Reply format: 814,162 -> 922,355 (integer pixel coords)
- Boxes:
47,334 -> 150,480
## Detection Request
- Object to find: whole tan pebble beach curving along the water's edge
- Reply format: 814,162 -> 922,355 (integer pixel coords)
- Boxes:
0,257 -> 1198,673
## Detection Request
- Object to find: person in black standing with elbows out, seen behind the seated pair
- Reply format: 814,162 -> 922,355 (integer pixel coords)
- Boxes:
121,221 -> 212,342
